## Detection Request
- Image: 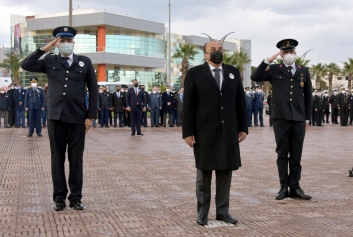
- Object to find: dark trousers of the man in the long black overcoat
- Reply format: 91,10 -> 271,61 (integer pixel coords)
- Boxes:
196,169 -> 232,215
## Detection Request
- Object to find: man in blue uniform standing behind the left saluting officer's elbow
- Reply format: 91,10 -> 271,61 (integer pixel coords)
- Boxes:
25,77 -> 45,137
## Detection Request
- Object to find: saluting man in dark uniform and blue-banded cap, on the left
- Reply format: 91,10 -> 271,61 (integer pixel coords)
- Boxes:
22,26 -> 98,211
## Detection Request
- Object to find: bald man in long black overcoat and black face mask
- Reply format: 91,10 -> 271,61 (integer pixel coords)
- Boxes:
182,40 -> 248,225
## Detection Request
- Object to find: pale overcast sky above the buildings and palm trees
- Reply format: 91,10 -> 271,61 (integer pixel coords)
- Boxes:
0,0 -> 353,66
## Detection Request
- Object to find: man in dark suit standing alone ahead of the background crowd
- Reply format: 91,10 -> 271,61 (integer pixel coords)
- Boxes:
126,79 -> 146,136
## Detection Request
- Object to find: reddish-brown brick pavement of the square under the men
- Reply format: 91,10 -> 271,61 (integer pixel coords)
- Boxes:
0,116 -> 353,237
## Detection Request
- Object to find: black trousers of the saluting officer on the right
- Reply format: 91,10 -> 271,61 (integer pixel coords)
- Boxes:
272,119 -> 305,189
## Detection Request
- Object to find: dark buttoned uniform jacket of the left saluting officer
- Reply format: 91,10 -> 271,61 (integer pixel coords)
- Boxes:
21,49 -> 98,124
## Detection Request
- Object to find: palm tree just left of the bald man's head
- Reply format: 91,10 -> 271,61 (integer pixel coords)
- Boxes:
172,44 -> 198,87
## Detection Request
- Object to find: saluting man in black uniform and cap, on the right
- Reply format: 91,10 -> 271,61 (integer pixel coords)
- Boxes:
251,39 -> 312,200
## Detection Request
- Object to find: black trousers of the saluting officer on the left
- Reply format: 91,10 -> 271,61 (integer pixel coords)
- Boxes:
48,120 -> 85,202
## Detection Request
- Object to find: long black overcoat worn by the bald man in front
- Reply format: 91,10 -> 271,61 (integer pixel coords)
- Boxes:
182,62 -> 248,170
